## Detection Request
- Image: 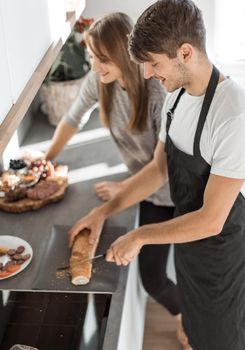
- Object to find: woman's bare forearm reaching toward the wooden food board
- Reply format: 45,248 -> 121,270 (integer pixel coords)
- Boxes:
45,120 -> 77,160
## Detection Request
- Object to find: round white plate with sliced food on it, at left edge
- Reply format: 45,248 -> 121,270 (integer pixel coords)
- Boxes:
0,235 -> 33,280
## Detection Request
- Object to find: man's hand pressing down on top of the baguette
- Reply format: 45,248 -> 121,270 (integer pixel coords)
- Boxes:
68,208 -> 105,248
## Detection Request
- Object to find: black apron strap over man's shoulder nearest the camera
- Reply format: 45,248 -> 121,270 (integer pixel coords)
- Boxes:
193,66 -> 219,156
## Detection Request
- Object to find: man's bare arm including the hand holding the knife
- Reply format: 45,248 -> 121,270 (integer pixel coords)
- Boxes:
107,174 -> 244,265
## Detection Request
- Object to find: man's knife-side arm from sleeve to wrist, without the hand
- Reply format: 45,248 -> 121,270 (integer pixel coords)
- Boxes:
143,174 -> 244,244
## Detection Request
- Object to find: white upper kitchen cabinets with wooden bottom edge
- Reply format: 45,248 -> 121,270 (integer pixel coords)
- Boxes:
0,0 -> 85,155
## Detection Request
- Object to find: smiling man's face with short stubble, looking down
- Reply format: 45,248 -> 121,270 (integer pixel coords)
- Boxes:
143,53 -> 190,92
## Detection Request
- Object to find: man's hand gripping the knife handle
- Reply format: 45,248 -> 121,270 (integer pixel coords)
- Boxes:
106,229 -> 143,266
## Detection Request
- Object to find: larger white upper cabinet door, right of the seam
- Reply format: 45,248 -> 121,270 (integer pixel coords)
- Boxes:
0,0 -> 65,102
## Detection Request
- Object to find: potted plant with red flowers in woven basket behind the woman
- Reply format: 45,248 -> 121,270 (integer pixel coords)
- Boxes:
40,16 -> 93,126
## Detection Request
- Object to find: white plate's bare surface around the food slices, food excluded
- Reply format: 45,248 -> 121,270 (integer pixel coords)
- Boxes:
0,236 -> 33,280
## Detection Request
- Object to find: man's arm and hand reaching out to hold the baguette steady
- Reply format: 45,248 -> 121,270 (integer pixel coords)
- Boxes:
69,141 -> 167,246
